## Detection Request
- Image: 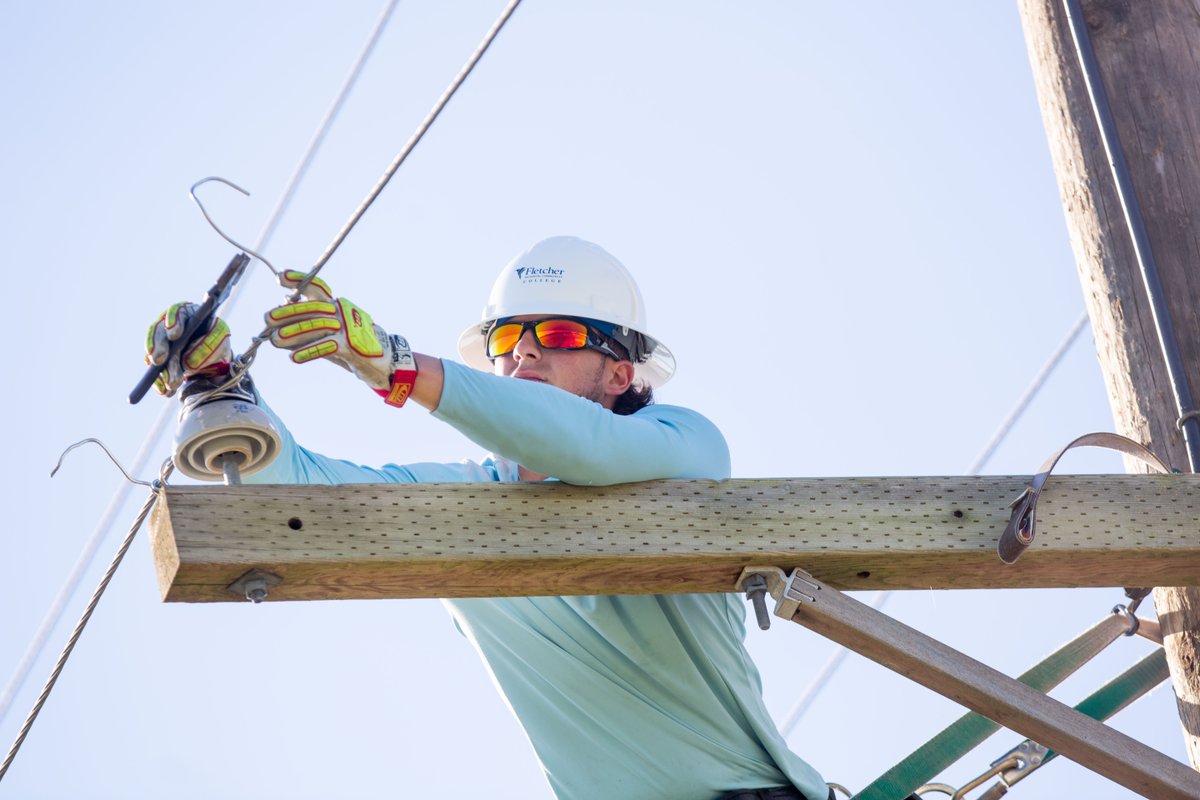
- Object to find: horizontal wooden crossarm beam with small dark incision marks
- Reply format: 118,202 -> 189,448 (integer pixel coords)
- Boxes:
151,475 -> 1200,602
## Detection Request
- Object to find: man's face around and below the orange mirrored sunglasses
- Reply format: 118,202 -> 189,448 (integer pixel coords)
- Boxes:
493,315 -> 632,408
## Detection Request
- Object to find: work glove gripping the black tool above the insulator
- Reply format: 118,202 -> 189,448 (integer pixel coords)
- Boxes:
146,302 -> 233,397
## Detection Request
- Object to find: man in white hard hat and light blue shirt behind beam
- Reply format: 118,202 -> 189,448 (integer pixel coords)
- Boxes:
148,236 -> 832,800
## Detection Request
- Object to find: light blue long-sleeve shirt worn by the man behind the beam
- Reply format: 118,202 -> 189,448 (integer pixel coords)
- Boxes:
247,361 -> 828,800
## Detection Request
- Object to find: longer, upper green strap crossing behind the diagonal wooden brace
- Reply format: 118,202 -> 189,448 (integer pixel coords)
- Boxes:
853,614 -> 1128,800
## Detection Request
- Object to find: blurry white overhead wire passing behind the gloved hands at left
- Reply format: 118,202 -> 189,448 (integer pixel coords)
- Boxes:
0,0 -> 400,738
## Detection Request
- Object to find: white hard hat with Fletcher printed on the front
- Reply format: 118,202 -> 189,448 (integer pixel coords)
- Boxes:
458,236 -> 674,387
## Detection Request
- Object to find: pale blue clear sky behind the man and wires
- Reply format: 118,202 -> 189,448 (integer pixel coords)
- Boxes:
0,0 -> 1183,799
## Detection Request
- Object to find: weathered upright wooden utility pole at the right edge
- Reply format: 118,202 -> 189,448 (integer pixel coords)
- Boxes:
1018,0 -> 1200,769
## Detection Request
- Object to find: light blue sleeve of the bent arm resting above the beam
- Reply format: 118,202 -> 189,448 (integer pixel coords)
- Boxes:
433,361 -> 730,486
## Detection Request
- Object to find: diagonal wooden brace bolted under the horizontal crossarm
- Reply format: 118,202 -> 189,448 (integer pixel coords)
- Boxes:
738,566 -> 1200,800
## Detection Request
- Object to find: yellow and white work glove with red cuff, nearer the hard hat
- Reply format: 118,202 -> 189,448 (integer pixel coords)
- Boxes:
266,270 -> 416,405
